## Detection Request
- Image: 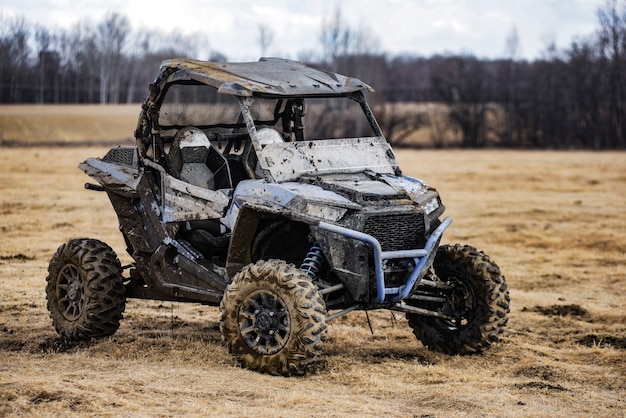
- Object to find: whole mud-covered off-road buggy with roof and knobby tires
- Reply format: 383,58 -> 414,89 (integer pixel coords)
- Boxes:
46,58 -> 509,376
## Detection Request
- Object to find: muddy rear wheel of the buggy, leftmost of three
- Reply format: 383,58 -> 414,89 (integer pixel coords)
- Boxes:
46,238 -> 126,341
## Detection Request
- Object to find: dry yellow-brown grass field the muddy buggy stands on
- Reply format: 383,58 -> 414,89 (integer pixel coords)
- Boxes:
0,105 -> 626,417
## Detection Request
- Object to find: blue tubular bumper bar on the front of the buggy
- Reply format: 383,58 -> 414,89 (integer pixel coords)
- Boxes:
319,217 -> 452,303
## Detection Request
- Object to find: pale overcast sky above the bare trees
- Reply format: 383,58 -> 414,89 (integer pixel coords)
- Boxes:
0,0 -> 605,61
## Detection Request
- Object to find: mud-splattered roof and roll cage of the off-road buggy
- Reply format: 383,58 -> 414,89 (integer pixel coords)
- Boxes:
135,58 -> 397,186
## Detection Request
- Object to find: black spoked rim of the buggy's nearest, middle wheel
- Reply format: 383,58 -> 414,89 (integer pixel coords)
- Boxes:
239,290 -> 290,354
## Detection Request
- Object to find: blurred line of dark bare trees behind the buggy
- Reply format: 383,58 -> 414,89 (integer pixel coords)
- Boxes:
0,0 -> 626,149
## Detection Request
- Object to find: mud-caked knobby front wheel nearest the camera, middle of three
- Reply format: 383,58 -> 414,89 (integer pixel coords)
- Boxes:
220,260 -> 327,376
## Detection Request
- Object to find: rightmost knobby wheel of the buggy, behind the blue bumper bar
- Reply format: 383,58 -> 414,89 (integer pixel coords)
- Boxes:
407,244 -> 510,354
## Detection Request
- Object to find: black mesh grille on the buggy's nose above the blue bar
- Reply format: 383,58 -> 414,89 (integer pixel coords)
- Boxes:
363,212 -> 424,251
